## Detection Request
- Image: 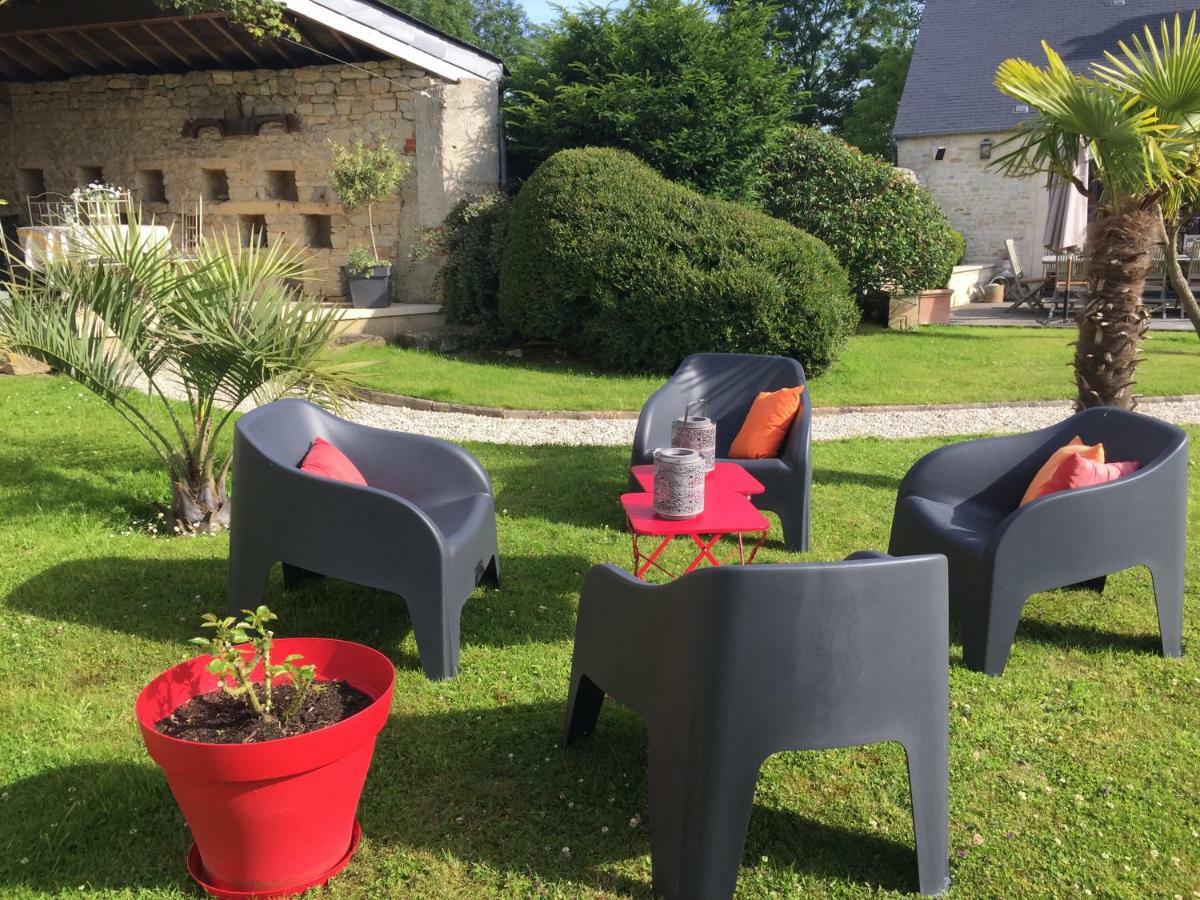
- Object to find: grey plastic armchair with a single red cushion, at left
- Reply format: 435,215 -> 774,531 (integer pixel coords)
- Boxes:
229,400 -> 499,678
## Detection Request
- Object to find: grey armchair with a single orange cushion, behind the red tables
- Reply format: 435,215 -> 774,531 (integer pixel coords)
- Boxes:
630,353 -> 812,551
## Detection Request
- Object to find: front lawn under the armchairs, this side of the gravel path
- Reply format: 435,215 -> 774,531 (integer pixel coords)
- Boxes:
0,378 -> 1200,899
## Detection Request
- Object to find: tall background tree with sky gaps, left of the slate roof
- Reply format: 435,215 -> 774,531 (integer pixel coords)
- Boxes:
722,0 -> 924,131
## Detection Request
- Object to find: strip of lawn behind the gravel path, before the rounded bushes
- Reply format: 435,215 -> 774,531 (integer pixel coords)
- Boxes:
346,326 -> 1200,409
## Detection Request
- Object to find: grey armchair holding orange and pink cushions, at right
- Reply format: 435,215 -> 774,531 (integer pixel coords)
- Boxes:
889,408 -> 1188,676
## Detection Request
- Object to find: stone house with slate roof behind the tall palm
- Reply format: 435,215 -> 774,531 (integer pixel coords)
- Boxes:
895,0 -> 1196,285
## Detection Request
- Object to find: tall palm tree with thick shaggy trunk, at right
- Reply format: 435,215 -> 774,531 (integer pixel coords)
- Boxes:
994,13 -> 1200,409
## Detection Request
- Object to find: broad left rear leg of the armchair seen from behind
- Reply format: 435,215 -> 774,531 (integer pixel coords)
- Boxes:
648,719 -> 761,900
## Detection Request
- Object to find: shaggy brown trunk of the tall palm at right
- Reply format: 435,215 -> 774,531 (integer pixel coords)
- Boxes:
1075,209 -> 1158,409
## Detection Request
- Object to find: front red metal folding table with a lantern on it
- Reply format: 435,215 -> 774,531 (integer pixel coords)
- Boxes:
620,489 -> 770,578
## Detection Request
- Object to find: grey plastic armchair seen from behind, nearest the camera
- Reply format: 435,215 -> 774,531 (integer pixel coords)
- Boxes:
563,553 -> 949,900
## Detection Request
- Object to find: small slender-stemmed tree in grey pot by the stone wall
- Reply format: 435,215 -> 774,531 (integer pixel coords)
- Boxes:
329,138 -> 409,308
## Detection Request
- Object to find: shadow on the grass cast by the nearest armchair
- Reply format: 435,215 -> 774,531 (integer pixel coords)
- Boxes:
360,702 -> 916,898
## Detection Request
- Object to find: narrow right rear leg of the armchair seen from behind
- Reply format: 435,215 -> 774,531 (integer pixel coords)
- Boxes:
905,732 -> 950,896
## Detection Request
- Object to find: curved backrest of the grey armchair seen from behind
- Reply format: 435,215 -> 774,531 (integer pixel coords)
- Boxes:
595,554 -> 949,751
